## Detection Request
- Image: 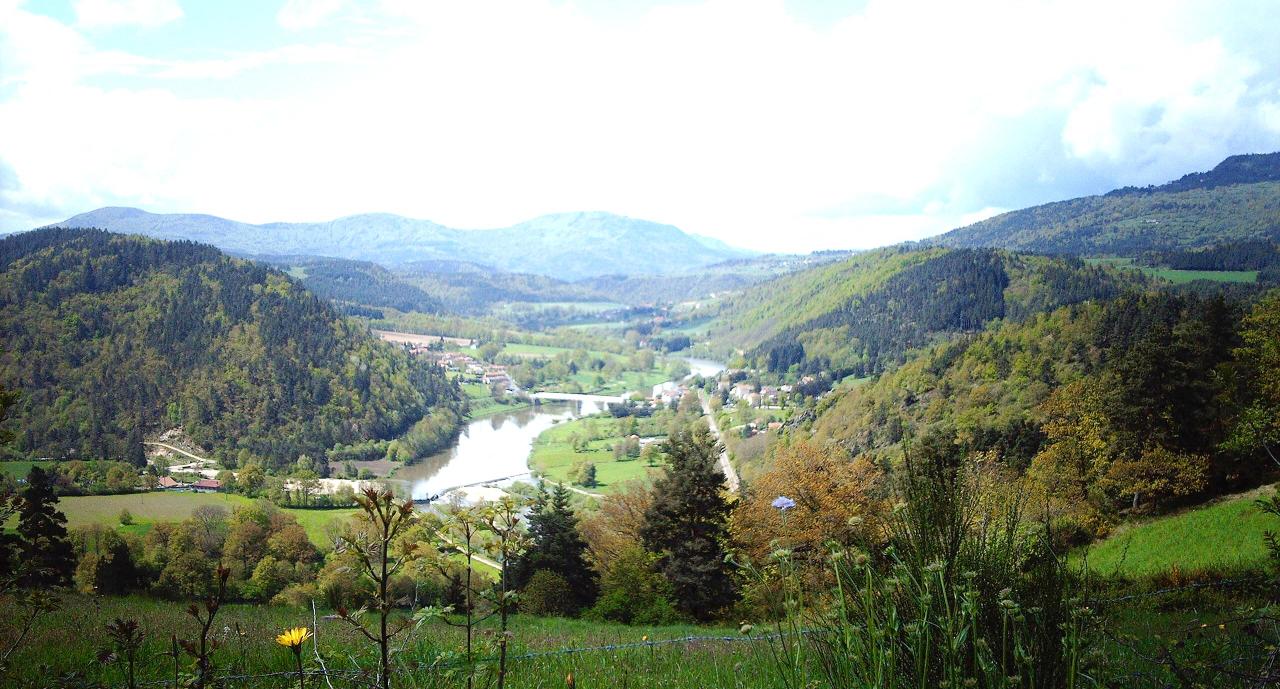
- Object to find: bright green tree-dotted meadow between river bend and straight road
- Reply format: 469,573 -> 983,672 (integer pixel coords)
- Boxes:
529,417 -> 662,493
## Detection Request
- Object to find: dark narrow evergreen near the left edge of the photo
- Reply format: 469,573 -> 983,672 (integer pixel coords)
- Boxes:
18,466 -> 76,588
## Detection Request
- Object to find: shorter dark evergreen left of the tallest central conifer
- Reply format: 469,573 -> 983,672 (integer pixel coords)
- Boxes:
513,484 -> 599,613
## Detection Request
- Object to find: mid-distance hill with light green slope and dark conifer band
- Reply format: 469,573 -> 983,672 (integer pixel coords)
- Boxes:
710,247 -> 1143,375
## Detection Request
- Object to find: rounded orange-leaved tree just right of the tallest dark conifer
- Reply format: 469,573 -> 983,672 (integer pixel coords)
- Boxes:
731,442 -> 883,562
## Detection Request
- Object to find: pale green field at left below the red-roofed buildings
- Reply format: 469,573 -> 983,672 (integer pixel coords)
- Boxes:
58,492 -> 356,547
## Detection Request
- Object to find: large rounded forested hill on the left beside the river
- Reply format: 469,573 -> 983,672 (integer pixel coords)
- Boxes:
0,229 -> 460,471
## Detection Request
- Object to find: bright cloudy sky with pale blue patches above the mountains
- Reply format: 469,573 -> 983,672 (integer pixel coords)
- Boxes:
0,0 -> 1280,251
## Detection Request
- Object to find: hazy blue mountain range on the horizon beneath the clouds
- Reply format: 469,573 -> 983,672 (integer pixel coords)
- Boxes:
45,207 -> 753,280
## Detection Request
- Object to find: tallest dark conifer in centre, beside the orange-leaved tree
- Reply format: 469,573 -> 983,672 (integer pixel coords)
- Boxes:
640,424 -> 736,620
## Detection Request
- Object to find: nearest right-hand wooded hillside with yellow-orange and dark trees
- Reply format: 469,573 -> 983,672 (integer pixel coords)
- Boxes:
813,289 -> 1280,522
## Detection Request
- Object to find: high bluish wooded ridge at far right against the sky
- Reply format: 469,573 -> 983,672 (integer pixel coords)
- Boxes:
929,152 -> 1280,256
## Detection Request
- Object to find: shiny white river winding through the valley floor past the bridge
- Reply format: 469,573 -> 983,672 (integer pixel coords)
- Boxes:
394,357 -> 724,499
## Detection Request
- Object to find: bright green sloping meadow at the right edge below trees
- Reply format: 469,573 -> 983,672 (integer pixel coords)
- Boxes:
1087,489 -> 1280,578
